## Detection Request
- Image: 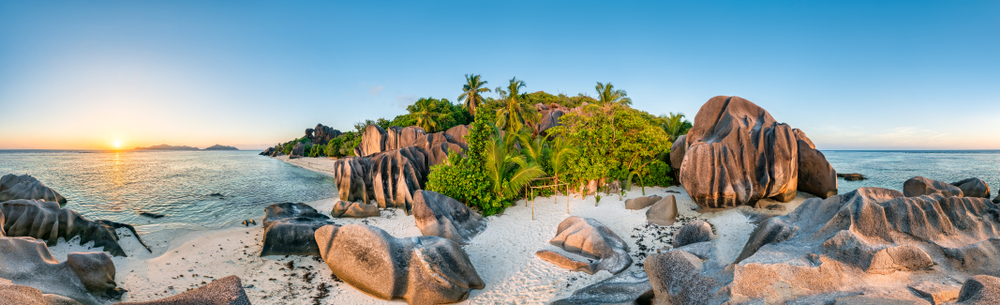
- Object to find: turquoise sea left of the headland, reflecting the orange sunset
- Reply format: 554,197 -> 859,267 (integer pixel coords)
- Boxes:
0,151 -> 337,232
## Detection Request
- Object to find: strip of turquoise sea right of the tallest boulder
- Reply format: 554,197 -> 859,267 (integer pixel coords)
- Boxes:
823,150 -> 1000,197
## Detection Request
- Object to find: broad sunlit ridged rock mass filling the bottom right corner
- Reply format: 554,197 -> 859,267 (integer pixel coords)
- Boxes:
644,183 -> 1000,304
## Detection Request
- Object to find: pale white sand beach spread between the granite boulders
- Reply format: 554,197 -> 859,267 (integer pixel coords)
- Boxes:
51,157 -> 813,304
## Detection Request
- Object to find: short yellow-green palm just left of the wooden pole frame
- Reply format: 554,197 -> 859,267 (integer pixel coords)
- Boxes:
483,127 -> 545,198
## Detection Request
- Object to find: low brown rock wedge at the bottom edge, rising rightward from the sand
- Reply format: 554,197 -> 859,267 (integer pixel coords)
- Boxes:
119,275 -> 250,305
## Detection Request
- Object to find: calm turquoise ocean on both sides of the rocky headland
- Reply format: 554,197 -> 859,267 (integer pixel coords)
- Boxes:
0,150 -> 1000,232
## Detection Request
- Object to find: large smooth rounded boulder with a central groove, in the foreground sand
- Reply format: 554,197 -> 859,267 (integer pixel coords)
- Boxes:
316,224 -> 486,304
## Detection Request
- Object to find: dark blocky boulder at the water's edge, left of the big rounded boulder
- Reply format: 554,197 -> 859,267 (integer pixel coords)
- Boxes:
260,202 -> 333,256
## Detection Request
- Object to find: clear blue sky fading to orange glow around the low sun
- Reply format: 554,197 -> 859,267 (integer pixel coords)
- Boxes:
0,0 -> 1000,149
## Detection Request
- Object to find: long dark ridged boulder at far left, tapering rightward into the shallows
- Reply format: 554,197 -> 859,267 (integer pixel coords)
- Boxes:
0,200 -> 152,256
